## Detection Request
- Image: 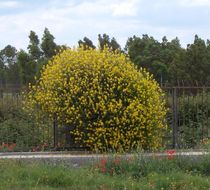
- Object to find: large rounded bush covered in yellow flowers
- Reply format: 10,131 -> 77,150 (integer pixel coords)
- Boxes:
27,48 -> 166,151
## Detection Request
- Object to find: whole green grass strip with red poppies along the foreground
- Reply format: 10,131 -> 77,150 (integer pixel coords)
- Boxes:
0,156 -> 210,190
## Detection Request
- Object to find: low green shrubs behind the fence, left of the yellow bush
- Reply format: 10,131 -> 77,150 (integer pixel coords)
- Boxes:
0,94 -> 52,151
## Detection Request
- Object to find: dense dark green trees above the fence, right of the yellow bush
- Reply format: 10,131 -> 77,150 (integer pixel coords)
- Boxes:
126,35 -> 210,85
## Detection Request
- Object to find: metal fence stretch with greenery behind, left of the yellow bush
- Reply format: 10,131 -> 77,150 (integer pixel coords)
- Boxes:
0,85 -> 54,151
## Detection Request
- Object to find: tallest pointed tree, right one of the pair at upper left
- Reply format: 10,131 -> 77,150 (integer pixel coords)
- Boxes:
41,28 -> 57,59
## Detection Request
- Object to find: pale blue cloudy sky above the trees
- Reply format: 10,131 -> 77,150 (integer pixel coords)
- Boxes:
0,0 -> 210,49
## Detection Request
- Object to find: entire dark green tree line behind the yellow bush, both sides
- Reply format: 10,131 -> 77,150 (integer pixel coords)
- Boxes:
0,28 -> 210,86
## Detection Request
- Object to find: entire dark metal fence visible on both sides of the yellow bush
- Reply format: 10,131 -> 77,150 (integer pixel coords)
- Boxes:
0,86 -> 210,151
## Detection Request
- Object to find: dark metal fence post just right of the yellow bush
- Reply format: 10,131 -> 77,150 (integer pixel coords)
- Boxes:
172,87 -> 178,148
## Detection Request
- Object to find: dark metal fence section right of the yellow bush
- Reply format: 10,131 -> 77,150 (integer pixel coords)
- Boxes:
163,86 -> 210,148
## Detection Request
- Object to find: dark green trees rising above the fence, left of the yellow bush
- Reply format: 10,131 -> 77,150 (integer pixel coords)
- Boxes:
0,28 -> 59,86
